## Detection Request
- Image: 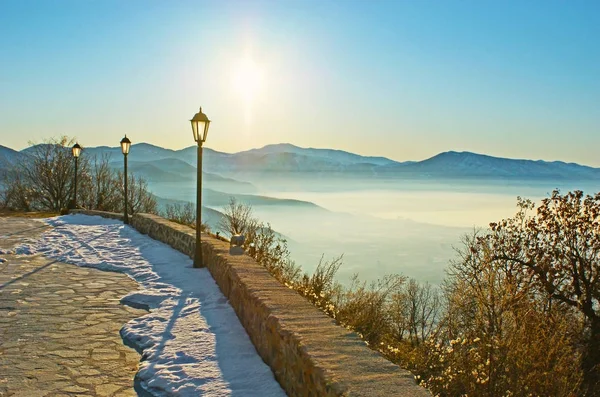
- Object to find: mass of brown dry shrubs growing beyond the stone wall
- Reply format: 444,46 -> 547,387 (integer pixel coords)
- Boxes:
209,192 -> 600,397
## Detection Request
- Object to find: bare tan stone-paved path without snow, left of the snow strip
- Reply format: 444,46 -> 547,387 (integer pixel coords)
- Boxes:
0,217 -> 146,397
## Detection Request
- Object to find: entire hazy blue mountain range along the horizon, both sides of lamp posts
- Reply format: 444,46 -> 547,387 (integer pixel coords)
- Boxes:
0,143 -> 600,180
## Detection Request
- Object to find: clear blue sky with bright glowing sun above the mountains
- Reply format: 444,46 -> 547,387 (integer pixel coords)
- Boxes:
0,0 -> 600,166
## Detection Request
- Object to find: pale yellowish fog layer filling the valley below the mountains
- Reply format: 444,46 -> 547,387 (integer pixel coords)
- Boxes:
150,175 -> 600,283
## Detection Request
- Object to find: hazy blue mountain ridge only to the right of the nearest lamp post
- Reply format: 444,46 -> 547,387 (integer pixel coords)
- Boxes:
204,144 -> 600,180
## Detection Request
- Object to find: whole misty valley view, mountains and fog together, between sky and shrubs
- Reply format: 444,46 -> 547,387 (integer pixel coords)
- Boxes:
0,143 -> 600,283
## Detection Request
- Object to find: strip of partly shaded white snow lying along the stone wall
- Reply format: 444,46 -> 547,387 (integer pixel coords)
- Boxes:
8,215 -> 285,397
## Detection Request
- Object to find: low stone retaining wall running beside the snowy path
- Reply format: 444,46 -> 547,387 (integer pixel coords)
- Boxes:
73,210 -> 430,397
